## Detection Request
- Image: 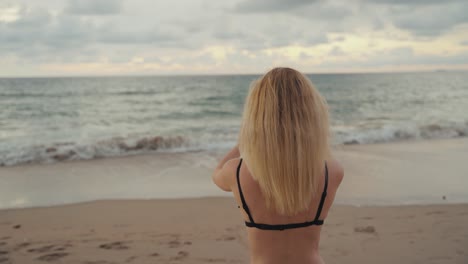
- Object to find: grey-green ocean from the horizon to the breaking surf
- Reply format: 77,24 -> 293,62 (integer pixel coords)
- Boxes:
0,72 -> 468,166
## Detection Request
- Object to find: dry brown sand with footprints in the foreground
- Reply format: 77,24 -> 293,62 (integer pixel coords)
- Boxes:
0,198 -> 468,264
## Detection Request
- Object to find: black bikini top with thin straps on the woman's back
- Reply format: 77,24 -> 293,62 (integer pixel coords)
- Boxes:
237,159 -> 328,230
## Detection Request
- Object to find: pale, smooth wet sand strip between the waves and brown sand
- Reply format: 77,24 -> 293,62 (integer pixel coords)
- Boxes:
0,138 -> 468,208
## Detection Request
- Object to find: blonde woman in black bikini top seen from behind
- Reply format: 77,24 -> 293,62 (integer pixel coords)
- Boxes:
213,68 -> 343,263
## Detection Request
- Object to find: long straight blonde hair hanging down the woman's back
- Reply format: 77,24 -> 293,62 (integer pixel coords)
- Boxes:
239,68 -> 329,215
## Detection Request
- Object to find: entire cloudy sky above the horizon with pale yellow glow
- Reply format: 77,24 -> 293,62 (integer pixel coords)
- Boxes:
0,0 -> 468,76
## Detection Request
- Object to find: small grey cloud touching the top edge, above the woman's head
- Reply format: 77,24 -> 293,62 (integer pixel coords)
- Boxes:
234,0 -> 319,13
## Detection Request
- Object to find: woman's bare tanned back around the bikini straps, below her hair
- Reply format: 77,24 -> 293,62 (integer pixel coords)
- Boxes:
225,158 -> 343,263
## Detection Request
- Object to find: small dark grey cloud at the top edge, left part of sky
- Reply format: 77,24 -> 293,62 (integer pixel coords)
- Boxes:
65,0 -> 122,15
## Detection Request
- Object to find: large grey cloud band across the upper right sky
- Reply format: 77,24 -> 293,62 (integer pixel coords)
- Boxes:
234,0 -> 468,37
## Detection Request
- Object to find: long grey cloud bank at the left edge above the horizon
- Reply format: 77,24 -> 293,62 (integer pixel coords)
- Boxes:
0,3 -> 196,61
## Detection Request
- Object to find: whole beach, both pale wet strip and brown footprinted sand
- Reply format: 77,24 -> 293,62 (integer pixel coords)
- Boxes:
0,138 -> 468,264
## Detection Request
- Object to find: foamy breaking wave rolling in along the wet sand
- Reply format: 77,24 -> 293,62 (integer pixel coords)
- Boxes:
0,122 -> 468,166
